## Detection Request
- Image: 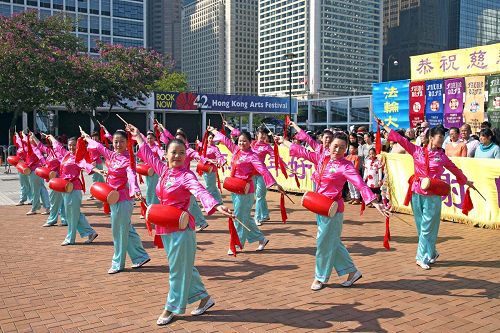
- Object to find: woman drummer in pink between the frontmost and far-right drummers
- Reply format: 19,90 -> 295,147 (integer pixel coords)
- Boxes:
284,130 -> 389,291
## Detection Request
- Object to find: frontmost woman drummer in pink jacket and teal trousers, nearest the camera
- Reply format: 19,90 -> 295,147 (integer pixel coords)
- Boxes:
127,124 -> 232,325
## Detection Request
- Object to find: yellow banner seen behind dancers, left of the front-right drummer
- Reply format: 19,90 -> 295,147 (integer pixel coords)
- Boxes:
217,144 -> 315,193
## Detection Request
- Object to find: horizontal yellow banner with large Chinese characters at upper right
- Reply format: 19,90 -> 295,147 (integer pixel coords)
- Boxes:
410,43 -> 500,81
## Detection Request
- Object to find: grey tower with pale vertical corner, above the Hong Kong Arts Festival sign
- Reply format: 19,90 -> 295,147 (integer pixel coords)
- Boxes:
182,0 -> 258,94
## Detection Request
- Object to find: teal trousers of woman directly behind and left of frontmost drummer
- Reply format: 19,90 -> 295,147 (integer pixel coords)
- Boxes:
110,200 -> 149,270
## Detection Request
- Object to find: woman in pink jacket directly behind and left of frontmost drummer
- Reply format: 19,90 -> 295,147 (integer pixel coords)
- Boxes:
82,130 -> 150,274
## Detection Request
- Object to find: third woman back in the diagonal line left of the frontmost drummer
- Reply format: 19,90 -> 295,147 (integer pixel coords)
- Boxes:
48,135 -> 97,246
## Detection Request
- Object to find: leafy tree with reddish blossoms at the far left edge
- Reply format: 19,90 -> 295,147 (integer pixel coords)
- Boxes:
0,11 -> 80,128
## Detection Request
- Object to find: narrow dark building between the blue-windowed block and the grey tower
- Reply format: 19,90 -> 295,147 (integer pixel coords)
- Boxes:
147,0 -> 182,71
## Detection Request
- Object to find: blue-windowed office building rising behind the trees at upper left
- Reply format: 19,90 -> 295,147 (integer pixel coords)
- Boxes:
0,0 -> 146,53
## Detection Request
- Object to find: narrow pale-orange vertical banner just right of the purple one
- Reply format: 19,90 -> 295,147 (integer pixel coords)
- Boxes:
464,76 -> 484,133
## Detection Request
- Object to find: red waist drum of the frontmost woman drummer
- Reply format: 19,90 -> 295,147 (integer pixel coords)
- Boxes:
145,204 -> 189,230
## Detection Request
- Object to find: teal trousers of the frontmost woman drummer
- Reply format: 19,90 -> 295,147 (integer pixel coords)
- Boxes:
161,228 -> 208,314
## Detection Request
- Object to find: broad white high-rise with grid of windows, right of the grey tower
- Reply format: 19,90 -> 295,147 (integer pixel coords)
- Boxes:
259,0 -> 382,97
